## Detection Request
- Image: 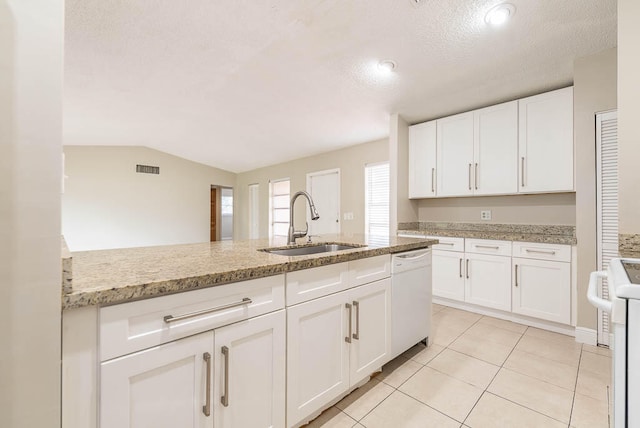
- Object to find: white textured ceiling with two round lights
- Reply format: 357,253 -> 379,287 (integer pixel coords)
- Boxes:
64,0 -> 616,172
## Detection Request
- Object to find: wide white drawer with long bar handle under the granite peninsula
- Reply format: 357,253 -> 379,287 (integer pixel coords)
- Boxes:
100,275 -> 284,361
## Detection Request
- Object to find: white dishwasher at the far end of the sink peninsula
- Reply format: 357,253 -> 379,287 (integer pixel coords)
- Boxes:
391,249 -> 431,358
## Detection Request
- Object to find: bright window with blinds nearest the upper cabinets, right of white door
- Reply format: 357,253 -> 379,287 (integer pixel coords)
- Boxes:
364,162 -> 389,239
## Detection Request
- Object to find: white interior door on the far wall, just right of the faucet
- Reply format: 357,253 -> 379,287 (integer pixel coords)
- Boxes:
307,169 -> 340,235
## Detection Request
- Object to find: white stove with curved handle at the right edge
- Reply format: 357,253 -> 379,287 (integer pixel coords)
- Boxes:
587,258 -> 640,428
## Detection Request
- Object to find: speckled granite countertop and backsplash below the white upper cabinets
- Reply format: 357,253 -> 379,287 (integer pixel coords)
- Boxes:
398,222 -> 577,245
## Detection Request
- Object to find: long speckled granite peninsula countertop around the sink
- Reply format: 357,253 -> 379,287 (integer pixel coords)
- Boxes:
62,234 -> 437,310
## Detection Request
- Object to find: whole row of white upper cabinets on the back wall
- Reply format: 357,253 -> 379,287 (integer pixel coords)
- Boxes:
409,88 -> 574,198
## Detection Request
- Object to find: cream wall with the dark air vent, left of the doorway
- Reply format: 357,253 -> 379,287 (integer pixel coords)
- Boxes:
62,146 -> 236,251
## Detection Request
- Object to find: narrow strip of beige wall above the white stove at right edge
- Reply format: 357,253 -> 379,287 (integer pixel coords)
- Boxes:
618,0 -> 640,236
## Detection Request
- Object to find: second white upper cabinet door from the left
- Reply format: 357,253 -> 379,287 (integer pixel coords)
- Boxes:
436,112 -> 473,196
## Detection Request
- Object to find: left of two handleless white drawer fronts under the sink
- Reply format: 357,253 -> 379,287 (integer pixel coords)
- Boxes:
287,263 -> 349,306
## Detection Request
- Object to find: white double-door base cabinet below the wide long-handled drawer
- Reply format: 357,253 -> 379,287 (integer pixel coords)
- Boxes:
100,310 -> 286,428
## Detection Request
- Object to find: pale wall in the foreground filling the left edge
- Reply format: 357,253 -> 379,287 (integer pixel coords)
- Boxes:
0,0 -> 64,428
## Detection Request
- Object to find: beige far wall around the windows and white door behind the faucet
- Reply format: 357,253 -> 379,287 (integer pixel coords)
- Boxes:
234,140 -> 389,239
